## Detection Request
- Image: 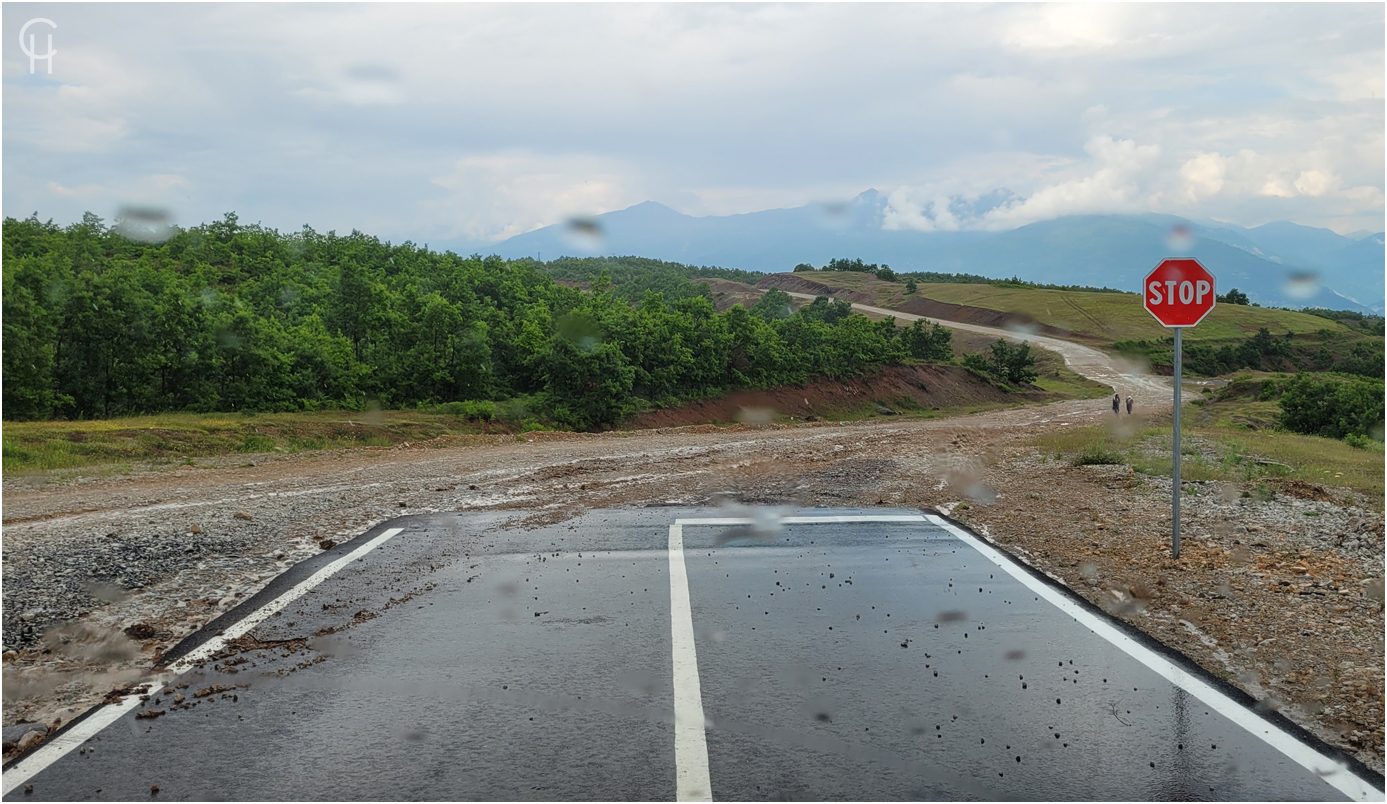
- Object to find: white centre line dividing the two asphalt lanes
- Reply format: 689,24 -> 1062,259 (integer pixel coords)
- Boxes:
670,521 -> 713,801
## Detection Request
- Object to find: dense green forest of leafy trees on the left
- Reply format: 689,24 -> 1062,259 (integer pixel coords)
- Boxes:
3,213 -> 951,430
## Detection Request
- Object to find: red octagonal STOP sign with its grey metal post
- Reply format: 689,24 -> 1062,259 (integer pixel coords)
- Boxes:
1142,258 -> 1218,559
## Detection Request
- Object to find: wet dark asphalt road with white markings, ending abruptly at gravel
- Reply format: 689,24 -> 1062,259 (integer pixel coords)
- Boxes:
4,507 -> 1383,801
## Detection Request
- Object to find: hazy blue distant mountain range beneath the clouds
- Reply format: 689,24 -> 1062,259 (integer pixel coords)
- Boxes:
460,190 -> 1384,313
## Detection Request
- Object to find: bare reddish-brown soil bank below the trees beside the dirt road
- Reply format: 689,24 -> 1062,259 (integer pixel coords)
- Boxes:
627,363 -> 1050,430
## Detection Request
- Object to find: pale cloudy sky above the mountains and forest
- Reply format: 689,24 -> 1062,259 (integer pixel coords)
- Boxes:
3,3 -> 1384,243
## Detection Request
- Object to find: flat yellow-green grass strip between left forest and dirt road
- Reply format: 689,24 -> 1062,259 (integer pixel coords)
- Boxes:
3,410 -> 499,475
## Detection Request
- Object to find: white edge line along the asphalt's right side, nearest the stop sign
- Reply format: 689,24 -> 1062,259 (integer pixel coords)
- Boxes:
928,514 -> 1383,801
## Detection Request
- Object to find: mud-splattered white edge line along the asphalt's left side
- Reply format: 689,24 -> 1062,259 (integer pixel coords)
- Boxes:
0,528 -> 405,796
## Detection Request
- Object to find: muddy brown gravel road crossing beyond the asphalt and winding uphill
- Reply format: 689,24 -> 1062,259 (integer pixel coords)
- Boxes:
3,305 -> 1383,771
